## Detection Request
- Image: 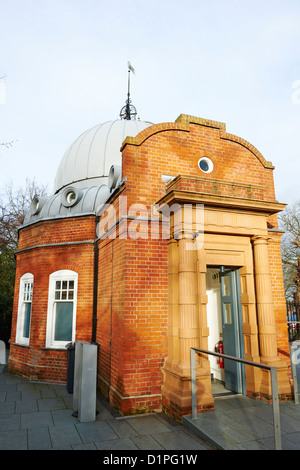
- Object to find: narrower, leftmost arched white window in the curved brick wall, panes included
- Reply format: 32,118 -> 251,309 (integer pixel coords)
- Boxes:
16,273 -> 33,345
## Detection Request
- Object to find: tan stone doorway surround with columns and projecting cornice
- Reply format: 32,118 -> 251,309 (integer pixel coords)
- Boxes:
158,182 -> 291,419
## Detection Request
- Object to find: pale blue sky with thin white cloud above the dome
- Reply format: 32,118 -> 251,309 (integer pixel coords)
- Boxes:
0,0 -> 300,204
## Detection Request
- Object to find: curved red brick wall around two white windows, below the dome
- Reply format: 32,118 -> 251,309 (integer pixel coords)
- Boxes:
9,217 -> 95,383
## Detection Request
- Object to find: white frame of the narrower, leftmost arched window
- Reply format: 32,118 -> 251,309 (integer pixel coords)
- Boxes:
16,273 -> 34,346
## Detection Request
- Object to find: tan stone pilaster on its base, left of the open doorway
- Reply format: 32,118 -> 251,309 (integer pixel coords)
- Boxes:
162,213 -> 213,416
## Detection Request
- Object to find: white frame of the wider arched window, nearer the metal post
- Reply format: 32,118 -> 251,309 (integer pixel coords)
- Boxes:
46,269 -> 78,349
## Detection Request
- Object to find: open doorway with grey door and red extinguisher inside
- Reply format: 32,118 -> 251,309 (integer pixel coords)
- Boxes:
206,266 -> 245,397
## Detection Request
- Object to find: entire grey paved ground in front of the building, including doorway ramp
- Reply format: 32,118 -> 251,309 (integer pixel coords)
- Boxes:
0,356 -> 300,453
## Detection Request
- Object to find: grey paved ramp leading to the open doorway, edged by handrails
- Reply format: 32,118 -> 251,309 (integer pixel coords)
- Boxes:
183,395 -> 300,450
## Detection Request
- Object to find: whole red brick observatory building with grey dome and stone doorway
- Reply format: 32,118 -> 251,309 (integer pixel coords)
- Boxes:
8,83 -> 291,419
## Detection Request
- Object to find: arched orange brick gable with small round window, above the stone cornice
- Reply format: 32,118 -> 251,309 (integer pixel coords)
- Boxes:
122,118 -> 275,204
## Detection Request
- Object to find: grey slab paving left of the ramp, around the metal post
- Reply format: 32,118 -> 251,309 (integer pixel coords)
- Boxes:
0,364 -> 214,452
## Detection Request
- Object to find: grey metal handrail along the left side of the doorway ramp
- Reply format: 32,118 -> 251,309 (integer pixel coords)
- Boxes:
191,348 -> 282,450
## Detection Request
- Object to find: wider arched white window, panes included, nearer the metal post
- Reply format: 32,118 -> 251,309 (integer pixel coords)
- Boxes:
46,270 -> 78,348
